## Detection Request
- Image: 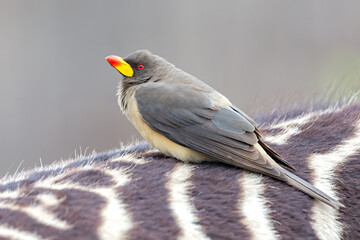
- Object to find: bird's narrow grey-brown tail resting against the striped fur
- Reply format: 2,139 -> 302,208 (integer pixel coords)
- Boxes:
282,169 -> 344,209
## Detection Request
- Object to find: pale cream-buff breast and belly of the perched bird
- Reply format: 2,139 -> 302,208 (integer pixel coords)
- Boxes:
121,92 -> 208,162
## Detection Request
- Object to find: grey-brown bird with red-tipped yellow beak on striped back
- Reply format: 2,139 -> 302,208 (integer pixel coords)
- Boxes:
105,50 -> 343,209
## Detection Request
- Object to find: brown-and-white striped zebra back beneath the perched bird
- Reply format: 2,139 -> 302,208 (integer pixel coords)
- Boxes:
0,104 -> 360,240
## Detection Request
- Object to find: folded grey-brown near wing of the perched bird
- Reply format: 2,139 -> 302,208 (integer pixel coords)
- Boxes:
136,83 -> 290,179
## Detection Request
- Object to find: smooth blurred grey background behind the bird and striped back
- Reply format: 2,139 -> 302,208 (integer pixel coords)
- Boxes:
0,0 -> 360,176
